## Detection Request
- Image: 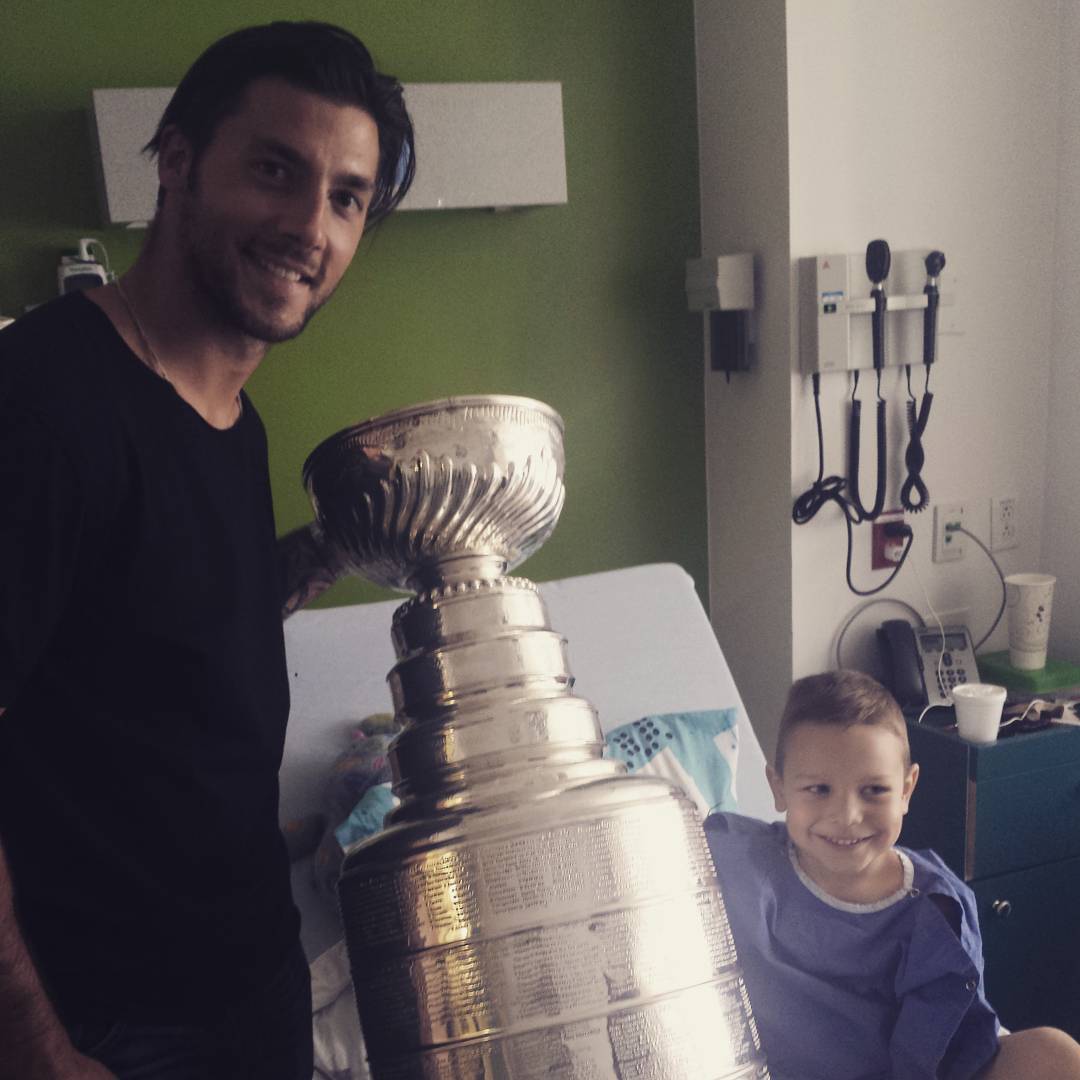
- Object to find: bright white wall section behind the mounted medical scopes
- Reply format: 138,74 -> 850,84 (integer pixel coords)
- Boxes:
787,0 -> 1061,676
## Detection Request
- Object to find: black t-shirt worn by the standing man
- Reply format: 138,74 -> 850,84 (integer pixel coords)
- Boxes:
0,294 -> 298,1020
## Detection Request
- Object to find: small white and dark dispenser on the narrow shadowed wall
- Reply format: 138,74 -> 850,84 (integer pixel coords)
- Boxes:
686,253 -> 754,379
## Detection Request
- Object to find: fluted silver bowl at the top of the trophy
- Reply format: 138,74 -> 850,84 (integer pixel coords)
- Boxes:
303,394 -> 565,592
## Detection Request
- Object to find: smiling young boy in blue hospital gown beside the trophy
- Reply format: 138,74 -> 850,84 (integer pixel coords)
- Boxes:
705,672 -> 1080,1080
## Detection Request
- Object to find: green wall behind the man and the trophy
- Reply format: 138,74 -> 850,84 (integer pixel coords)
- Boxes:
0,0 -> 707,603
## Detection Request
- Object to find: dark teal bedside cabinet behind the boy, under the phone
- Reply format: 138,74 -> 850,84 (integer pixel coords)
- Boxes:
900,711 -> 1080,1039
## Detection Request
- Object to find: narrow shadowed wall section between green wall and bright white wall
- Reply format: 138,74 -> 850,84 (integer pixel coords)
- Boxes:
688,0 -> 792,753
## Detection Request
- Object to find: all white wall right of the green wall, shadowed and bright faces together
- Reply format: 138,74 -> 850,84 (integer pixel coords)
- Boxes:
697,0 -> 1067,750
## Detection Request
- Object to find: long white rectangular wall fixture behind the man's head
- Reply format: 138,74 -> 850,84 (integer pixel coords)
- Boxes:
91,82 -> 567,226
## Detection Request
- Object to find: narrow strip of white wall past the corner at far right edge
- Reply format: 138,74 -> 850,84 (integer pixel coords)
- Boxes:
1041,0 -> 1080,661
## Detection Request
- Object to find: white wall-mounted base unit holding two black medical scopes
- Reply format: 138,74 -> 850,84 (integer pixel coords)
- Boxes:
799,249 -> 961,374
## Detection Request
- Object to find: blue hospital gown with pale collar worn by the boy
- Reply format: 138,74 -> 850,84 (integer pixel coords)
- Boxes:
705,813 -> 998,1080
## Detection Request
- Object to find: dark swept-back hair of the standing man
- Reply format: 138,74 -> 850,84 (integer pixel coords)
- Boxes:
144,22 -> 416,226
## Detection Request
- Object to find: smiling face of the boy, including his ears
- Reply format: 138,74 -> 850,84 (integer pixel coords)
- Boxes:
768,724 -> 918,903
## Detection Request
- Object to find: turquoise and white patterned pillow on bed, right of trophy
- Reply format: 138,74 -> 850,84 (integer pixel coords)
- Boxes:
604,708 -> 739,819
